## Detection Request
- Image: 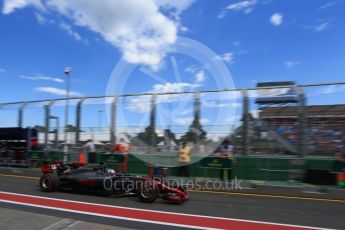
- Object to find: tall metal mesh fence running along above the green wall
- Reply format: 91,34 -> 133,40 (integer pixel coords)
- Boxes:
0,82 -> 345,155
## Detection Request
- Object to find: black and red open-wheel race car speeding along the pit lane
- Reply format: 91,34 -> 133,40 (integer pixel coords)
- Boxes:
39,162 -> 189,203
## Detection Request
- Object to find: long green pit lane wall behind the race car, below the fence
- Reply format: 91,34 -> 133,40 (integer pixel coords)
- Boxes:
21,151 -> 345,185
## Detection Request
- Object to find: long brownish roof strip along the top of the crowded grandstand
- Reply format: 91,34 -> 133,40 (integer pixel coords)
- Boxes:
260,104 -> 345,119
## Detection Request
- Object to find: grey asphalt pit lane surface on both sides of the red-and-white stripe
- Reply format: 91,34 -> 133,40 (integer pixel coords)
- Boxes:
0,175 -> 345,229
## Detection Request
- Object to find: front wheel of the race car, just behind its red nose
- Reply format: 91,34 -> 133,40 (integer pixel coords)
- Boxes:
137,180 -> 159,203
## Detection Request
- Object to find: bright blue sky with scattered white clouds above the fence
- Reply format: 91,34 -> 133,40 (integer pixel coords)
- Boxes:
0,0 -> 345,131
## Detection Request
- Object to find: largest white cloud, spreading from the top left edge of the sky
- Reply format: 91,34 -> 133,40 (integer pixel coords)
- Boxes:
3,0 -> 194,69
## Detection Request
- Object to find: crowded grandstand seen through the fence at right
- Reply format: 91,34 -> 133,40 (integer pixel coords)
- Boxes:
259,104 -> 345,155
